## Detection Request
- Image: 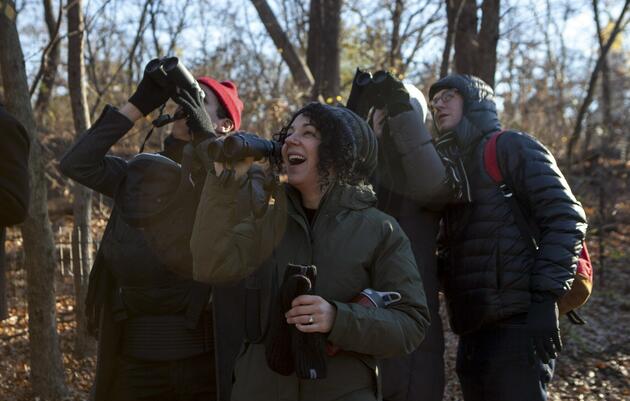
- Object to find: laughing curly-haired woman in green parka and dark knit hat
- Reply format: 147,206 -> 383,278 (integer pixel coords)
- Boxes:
191,103 -> 429,401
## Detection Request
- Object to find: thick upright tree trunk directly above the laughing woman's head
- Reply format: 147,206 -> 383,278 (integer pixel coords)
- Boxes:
306,0 -> 341,103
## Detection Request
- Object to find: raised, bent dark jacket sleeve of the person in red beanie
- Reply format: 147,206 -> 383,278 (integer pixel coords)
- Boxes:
59,106 -> 133,197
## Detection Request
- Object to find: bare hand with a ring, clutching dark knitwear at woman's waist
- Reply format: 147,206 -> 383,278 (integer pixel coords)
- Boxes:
285,295 -> 337,333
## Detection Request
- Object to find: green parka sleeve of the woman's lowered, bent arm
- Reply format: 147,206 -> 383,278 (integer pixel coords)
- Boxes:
328,220 -> 430,358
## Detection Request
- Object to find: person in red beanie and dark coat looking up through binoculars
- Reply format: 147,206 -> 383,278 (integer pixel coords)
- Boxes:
59,61 -> 248,401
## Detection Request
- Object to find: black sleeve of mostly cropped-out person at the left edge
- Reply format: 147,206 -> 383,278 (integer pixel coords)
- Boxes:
0,107 -> 30,227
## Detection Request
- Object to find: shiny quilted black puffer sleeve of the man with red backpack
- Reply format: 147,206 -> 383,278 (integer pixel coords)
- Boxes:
498,132 -> 586,302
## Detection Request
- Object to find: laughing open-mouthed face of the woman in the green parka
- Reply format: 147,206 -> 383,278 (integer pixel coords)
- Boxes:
282,114 -> 321,193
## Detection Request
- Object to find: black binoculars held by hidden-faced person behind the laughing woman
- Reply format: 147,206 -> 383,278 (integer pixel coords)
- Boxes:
346,68 -> 396,120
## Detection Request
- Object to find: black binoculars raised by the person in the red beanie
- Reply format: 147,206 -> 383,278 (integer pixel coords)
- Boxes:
144,57 -> 205,97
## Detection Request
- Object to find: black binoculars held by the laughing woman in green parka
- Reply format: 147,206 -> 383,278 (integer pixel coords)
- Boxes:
208,132 -> 282,162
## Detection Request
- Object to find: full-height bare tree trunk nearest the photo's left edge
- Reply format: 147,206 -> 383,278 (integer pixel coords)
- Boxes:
0,0 -> 67,400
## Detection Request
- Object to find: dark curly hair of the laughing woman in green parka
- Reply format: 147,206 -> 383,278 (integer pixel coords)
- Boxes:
276,102 -> 360,186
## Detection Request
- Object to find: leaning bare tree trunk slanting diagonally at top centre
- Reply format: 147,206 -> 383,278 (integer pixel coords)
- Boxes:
251,0 -> 315,92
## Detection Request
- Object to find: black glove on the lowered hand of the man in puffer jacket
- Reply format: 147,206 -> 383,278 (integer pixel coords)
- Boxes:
527,300 -> 562,363
